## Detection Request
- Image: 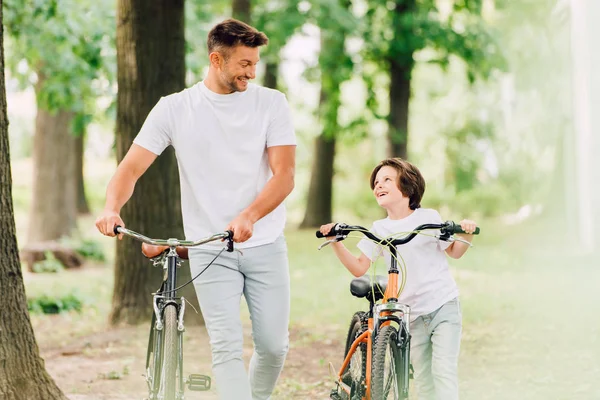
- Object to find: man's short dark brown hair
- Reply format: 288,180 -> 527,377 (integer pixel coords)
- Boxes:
207,18 -> 269,57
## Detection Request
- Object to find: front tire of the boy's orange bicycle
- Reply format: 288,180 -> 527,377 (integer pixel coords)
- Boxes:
371,325 -> 408,400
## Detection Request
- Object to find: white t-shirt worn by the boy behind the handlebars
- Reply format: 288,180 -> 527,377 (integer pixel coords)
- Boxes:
358,208 -> 458,321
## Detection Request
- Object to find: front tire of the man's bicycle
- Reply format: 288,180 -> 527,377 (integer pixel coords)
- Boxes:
161,304 -> 179,400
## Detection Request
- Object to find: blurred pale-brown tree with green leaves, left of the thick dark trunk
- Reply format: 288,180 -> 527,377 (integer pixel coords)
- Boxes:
6,0 -> 113,243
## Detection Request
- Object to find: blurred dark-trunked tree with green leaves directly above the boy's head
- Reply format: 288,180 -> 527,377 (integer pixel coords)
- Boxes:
364,0 -> 502,158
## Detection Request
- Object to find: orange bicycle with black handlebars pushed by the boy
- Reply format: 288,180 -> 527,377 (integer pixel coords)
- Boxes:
317,221 -> 479,400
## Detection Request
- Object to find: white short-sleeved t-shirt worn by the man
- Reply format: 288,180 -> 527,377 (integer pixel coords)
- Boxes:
133,82 -> 296,248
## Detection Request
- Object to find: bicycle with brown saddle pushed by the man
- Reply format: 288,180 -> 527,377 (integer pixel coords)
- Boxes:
114,226 -> 233,400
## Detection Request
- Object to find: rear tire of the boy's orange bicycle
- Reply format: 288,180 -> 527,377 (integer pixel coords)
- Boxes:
342,311 -> 367,400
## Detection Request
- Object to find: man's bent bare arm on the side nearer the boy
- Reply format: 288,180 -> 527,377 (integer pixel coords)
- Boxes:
226,146 -> 296,242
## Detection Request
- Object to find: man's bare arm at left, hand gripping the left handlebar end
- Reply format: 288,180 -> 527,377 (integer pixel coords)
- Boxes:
96,144 -> 158,236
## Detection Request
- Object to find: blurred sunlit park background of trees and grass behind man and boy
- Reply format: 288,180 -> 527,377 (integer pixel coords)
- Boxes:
4,0 -> 600,399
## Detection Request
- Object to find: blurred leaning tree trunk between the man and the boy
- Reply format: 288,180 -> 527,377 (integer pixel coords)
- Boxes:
300,0 -> 356,228
